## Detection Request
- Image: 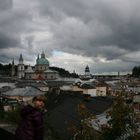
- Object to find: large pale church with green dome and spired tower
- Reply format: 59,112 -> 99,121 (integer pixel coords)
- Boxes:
12,52 -> 59,80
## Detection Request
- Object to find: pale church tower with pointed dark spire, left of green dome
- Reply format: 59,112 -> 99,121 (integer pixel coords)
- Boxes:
18,54 -> 25,78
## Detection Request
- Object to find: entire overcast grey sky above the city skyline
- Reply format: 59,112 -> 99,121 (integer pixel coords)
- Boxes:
0,0 -> 140,74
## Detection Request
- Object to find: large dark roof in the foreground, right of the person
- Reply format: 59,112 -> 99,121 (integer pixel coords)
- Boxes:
45,93 -> 113,140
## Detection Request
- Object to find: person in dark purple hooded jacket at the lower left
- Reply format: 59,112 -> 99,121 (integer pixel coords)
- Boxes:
15,95 -> 46,140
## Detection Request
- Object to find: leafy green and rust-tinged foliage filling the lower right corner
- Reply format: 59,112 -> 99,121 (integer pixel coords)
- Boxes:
73,94 -> 140,140
